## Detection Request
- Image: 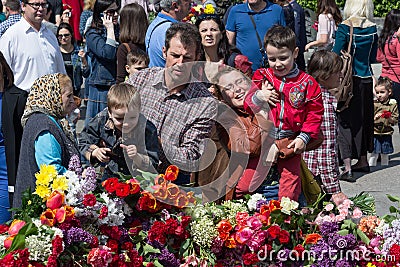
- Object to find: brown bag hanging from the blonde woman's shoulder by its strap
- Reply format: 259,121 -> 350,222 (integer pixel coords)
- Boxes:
329,21 -> 353,112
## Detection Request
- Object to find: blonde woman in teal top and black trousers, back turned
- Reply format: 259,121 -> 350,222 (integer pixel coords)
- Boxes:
333,0 -> 378,182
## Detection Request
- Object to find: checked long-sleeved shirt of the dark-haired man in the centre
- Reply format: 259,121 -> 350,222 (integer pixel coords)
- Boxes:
127,67 -> 217,172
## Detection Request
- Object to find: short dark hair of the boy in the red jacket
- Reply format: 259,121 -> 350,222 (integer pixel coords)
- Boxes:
264,25 -> 296,52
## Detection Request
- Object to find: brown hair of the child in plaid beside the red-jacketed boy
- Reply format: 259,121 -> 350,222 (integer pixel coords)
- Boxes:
308,50 -> 343,83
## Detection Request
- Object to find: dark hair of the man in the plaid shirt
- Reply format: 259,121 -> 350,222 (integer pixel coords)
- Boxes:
165,23 -> 201,56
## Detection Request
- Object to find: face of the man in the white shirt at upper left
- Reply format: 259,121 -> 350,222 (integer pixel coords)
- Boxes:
22,0 -> 48,30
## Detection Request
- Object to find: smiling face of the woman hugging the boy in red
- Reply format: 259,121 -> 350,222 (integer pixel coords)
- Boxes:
218,71 -> 250,108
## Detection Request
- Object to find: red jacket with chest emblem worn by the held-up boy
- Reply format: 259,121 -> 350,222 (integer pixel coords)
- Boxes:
244,68 -> 324,139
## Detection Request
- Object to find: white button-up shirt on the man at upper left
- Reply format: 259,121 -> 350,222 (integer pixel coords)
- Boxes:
0,18 -> 66,92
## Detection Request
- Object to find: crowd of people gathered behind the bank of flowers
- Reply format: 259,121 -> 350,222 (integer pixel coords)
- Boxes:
0,0 -> 400,223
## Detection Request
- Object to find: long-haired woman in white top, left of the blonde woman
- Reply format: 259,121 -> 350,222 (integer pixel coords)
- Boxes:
305,0 -> 342,51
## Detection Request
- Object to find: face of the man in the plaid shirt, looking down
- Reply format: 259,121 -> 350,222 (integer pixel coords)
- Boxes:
163,36 -> 198,88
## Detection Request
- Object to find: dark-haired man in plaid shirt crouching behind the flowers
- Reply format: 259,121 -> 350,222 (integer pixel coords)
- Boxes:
128,23 -> 217,184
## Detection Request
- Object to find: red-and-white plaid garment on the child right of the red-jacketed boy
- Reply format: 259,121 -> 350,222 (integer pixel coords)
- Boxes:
303,87 -> 341,194
